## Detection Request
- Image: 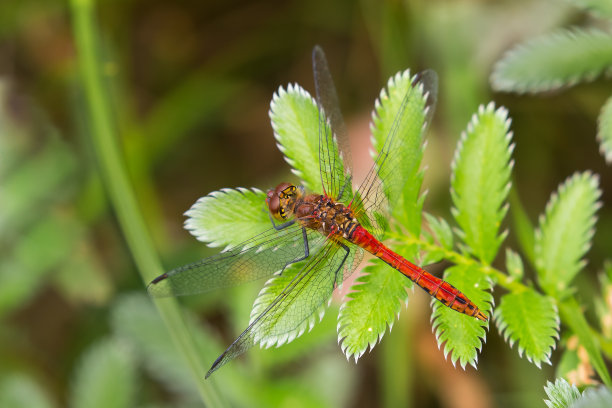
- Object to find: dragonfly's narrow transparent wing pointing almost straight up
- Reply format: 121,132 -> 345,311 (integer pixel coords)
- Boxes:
312,46 -> 352,201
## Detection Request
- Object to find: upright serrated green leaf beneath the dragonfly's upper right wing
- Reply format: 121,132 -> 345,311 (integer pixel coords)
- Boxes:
370,70 -> 436,231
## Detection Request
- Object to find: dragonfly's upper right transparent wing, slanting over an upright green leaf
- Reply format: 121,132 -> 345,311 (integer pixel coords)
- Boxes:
351,70 -> 438,239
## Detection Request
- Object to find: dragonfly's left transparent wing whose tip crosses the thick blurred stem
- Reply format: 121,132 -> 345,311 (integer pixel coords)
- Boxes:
148,223 -> 325,297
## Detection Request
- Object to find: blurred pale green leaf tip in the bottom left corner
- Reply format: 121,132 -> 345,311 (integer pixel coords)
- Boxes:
0,374 -> 55,408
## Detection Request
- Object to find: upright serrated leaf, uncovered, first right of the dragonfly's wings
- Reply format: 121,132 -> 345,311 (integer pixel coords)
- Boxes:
451,103 -> 514,264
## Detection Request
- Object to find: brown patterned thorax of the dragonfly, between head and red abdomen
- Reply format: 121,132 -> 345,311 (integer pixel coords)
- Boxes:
294,194 -> 359,240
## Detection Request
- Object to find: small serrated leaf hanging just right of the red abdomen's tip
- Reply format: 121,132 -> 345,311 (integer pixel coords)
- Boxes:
494,289 -> 559,368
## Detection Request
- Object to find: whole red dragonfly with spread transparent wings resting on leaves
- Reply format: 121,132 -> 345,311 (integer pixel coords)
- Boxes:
148,46 -> 488,378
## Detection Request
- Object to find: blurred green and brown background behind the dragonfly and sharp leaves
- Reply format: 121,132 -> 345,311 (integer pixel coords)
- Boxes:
0,0 -> 612,407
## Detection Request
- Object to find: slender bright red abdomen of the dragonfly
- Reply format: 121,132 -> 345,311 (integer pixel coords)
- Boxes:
349,226 -> 488,321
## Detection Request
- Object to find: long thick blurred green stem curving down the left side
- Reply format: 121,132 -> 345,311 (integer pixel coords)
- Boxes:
70,0 -> 222,407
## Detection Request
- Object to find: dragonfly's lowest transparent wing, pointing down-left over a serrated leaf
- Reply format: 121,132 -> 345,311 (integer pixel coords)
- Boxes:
206,240 -> 360,377
